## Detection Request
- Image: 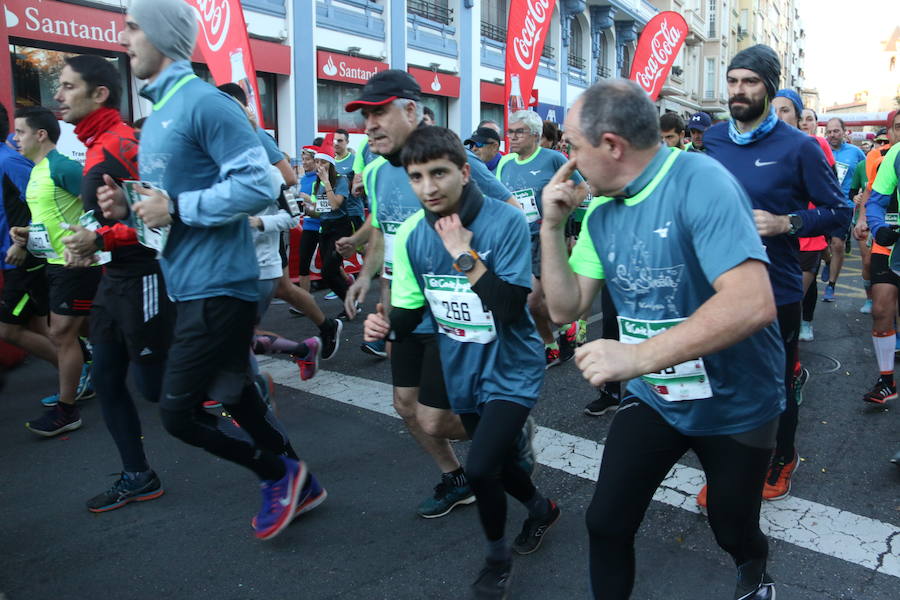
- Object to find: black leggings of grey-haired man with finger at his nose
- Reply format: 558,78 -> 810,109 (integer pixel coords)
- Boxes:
584,395 -> 775,600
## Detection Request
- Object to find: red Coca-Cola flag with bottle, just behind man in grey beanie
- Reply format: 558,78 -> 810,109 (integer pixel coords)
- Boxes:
186,0 -> 265,127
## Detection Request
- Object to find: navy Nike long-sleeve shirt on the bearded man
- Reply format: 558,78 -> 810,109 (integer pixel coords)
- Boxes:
703,121 -> 852,306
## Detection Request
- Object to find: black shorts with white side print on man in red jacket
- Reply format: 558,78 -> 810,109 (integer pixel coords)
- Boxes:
91,273 -> 175,363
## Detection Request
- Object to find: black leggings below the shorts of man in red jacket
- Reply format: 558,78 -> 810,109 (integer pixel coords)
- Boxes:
91,340 -> 165,472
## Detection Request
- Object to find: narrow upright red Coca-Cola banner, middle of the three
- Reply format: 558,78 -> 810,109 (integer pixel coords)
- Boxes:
503,0 -> 556,130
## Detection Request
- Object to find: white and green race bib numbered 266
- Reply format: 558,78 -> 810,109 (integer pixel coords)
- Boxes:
423,275 -> 497,344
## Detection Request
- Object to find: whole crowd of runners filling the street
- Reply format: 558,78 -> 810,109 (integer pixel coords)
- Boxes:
0,0 -> 900,600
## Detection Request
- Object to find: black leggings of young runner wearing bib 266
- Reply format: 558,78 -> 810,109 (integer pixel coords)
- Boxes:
460,400 -> 535,542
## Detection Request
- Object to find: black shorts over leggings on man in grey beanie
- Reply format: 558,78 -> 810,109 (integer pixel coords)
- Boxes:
160,296 -> 256,411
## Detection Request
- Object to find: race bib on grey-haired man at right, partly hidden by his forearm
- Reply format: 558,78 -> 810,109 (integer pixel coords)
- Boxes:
616,316 -> 712,402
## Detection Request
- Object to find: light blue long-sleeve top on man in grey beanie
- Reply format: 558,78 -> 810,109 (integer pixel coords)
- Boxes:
138,61 -> 271,301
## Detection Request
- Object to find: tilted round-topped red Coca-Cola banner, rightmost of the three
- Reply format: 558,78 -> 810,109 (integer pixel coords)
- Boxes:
629,11 -> 688,100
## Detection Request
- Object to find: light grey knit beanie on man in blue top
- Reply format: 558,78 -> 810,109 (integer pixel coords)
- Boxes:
128,0 -> 197,60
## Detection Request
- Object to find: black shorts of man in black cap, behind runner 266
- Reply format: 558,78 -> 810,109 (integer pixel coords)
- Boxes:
391,333 -> 450,410
